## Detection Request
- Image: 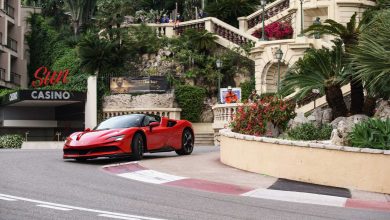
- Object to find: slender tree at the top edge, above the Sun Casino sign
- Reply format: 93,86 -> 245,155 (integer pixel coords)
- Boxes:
65,0 -> 97,36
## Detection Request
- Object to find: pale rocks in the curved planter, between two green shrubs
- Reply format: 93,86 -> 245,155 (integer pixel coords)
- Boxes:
330,115 -> 369,145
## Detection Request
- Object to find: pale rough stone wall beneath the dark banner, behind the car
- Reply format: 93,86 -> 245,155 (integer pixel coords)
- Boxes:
103,93 -> 175,109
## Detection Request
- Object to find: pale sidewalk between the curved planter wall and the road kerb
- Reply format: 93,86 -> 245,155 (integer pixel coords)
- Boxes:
139,146 -> 390,202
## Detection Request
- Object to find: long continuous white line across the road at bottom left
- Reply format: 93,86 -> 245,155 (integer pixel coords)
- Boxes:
0,193 -> 164,220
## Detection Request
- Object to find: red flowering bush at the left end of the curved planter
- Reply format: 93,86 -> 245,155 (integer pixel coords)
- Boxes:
230,96 -> 295,136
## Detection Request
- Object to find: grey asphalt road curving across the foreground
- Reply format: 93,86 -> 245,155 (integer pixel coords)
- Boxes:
0,148 -> 390,220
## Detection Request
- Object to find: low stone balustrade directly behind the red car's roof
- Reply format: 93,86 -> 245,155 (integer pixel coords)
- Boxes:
103,108 -> 181,120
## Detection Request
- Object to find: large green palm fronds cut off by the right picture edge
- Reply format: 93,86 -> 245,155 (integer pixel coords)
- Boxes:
351,10 -> 390,99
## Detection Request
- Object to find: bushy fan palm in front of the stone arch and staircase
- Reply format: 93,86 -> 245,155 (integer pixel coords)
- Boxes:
282,42 -> 350,118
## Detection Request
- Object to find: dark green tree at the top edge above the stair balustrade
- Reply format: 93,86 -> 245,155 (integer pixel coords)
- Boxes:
205,0 -> 260,27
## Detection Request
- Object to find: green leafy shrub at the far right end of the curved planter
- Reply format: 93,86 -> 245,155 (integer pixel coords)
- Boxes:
348,119 -> 390,150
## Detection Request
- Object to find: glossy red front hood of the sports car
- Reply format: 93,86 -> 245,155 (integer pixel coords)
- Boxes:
66,128 -> 131,146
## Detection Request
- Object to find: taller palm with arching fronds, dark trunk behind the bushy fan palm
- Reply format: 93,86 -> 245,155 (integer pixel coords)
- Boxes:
304,13 -> 364,114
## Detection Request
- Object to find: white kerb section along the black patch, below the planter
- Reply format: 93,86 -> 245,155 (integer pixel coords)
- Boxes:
242,189 -> 347,207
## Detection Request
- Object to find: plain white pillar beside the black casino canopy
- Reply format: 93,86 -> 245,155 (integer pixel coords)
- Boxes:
84,76 -> 97,129
